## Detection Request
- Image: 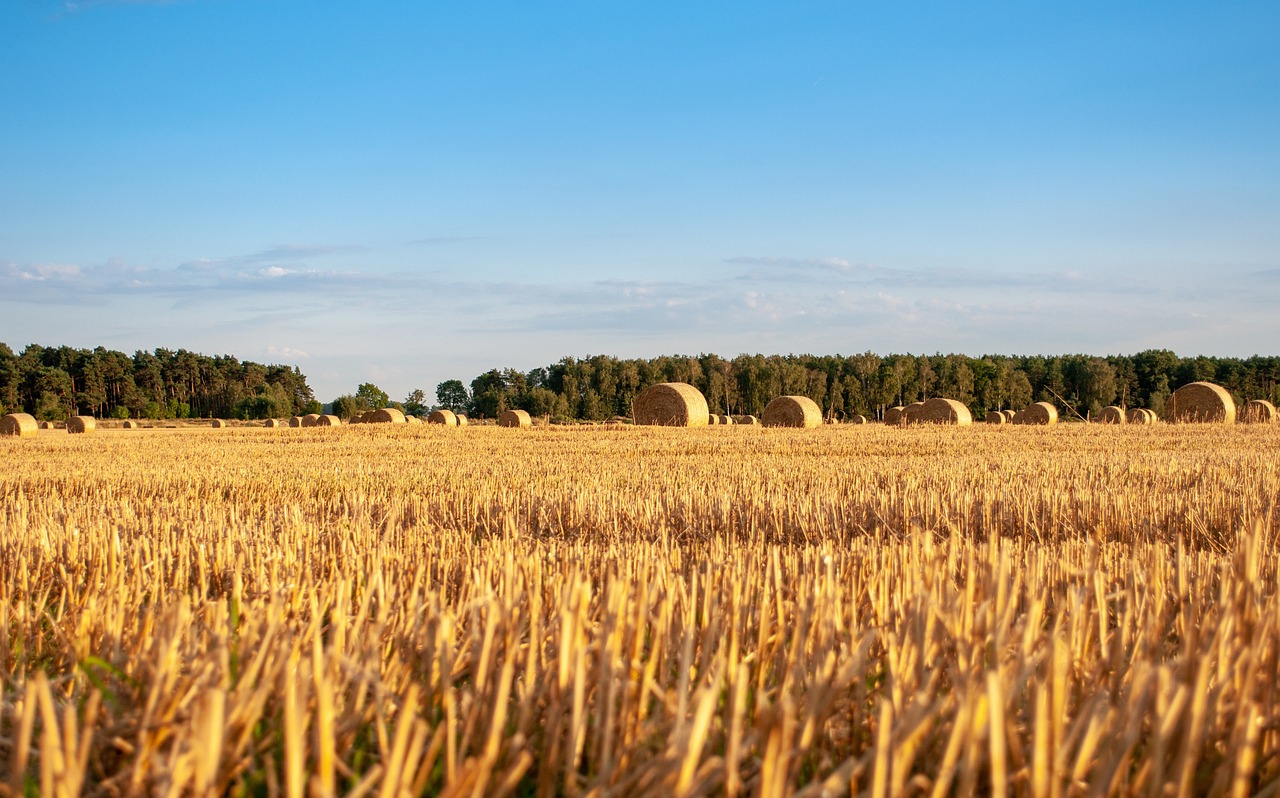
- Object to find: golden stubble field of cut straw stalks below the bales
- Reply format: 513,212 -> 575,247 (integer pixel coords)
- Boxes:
0,425 -> 1280,797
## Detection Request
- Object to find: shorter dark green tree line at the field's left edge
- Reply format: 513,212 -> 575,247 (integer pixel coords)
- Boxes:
0,343 -> 320,420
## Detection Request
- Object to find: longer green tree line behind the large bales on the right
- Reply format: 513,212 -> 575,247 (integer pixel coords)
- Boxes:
436,350 -> 1280,420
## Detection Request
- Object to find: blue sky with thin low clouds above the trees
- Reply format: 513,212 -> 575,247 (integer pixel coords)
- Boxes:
0,0 -> 1280,400
